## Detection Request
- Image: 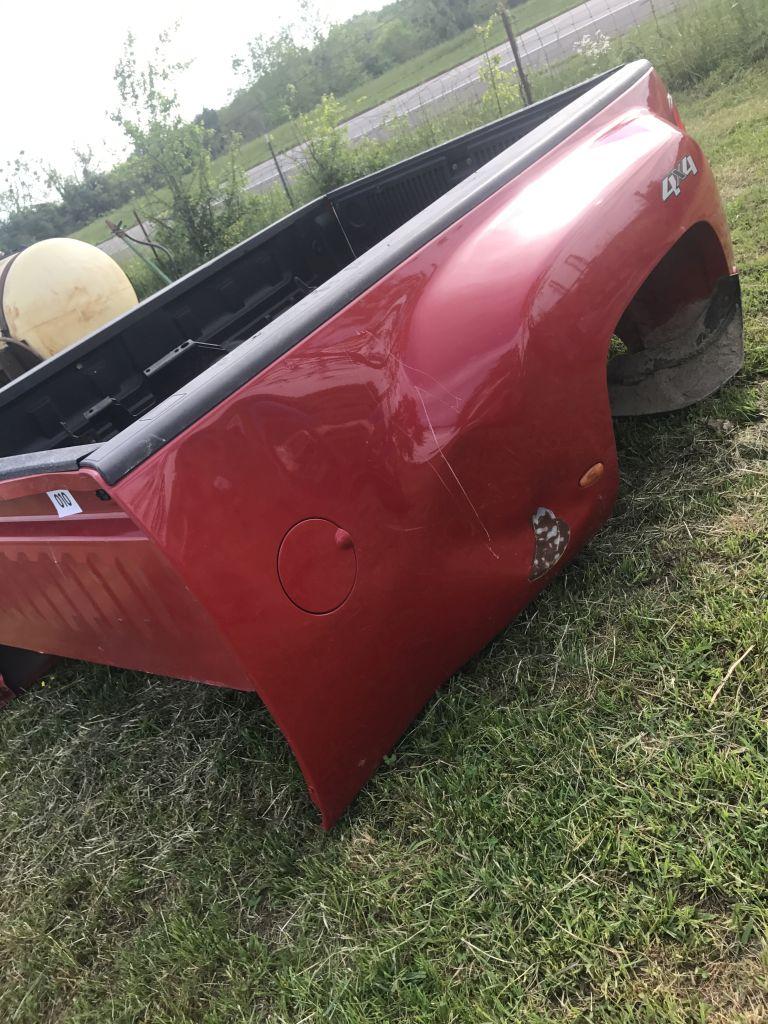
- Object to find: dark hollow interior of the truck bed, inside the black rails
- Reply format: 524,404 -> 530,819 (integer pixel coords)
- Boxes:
0,73 -> 611,458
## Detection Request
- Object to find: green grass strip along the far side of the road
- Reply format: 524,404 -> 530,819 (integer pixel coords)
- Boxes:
73,0 -> 581,245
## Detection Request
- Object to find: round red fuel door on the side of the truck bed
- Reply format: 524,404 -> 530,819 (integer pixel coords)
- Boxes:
278,519 -> 357,615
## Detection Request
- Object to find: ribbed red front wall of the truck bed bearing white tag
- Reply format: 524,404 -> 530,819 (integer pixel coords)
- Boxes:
0,473 -> 249,686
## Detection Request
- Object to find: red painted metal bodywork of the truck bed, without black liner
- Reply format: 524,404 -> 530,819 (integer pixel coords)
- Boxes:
0,68 -> 732,825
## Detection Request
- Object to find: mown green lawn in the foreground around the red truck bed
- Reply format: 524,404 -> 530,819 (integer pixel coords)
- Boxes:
0,65 -> 768,1024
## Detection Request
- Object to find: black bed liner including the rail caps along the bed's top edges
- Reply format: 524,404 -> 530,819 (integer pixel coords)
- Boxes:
0,60 -> 650,483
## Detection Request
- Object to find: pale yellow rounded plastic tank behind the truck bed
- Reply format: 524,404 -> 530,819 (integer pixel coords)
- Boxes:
0,239 -> 138,359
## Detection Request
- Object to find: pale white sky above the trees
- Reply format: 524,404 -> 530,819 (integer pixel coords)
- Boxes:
0,0 -> 384,180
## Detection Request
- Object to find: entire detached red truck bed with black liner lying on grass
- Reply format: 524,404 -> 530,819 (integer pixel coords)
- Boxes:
0,61 -> 741,826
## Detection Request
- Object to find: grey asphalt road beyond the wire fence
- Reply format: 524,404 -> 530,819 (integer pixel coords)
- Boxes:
100,0 -> 681,258
